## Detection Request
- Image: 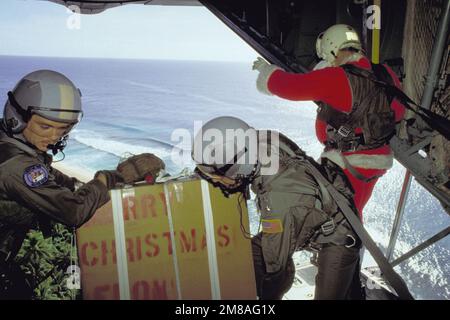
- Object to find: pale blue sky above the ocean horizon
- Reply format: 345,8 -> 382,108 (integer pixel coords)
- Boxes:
0,0 -> 258,61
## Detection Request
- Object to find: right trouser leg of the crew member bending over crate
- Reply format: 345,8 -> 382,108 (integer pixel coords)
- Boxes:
314,245 -> 365,300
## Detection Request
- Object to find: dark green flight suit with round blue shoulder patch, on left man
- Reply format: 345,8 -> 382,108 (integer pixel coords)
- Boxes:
0,129 -> 109,299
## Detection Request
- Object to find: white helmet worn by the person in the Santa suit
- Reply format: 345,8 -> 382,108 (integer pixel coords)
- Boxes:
316,24 -> 362,64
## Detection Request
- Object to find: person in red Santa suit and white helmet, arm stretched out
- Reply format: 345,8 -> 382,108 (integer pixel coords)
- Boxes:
253,24 -> 405,219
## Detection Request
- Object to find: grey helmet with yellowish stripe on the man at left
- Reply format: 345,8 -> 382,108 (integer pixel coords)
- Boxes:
3,70 -> 83,134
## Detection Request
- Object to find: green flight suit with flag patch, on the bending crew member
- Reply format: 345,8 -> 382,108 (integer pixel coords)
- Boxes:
251,134 -> 361,299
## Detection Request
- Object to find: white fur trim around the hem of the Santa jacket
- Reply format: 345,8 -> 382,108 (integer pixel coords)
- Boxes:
320,150 -> 394,170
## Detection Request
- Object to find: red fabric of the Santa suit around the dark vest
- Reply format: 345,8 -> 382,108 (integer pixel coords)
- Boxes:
267,57 -> 405,216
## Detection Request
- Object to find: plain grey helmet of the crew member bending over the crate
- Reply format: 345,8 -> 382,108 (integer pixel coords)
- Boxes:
192,117 -> 259,182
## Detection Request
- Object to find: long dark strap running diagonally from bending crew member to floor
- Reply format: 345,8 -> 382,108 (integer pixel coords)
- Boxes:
305,161 -> 414,300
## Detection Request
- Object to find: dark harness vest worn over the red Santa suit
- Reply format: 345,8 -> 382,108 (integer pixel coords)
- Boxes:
318,64 -> 395,152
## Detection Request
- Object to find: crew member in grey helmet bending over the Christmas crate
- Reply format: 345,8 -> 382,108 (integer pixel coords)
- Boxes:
192,117 -> 364,300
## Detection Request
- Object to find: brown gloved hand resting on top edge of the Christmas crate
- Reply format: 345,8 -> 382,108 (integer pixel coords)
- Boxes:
117,153 -> 166,184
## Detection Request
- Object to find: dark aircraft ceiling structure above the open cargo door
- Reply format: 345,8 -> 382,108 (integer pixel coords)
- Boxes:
39,0 -> 406,72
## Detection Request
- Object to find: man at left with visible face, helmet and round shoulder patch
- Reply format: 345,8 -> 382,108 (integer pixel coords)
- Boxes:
0,70 -> 165,299
